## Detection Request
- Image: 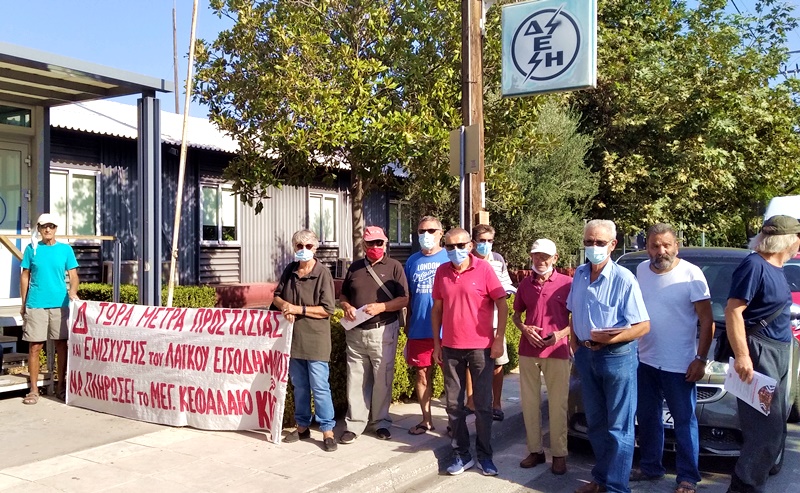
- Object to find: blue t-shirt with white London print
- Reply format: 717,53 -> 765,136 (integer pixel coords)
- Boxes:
405,249 -> 449,339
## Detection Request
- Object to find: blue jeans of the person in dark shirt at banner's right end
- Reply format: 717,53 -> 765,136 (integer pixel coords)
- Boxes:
289,358 -> 336,431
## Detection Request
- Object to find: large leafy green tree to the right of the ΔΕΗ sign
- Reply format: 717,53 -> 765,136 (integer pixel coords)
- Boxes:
571,0 -> 800,245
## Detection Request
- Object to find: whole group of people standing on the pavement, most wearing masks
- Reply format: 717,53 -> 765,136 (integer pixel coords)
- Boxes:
21,210 -> 800,493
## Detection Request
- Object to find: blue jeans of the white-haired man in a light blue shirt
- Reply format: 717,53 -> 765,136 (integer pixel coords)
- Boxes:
575,341 -> 639,493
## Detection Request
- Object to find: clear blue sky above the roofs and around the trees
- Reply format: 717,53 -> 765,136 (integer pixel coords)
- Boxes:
0,0 -> 800,117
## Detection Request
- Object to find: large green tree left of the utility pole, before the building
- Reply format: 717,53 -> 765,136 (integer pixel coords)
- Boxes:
196,0 -> 460,257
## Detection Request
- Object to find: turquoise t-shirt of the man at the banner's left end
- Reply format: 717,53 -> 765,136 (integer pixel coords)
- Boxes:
21,241 -> 78,308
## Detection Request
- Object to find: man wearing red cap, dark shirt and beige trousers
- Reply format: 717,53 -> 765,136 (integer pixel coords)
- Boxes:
340,226 -> 408,444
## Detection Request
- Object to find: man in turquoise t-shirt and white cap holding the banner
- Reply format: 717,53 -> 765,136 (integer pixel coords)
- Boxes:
19,213 -> 79,404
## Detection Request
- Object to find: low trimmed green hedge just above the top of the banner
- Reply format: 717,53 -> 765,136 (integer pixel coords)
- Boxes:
78,283 -> 217,308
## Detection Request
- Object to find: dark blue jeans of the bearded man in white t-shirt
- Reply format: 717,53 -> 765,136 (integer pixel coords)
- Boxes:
636,363 -> 700,484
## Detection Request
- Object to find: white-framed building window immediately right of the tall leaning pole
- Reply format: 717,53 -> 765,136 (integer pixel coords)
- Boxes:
200,184 -> 240,243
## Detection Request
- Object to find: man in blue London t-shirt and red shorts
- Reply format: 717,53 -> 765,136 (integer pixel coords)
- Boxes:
405,216 -> 448,435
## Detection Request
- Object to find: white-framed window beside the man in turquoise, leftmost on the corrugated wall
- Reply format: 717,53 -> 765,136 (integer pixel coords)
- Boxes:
50,169 -> 98,236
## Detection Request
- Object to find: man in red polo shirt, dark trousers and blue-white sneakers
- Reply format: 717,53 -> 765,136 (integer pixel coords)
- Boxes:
431,228 -> 508,476
